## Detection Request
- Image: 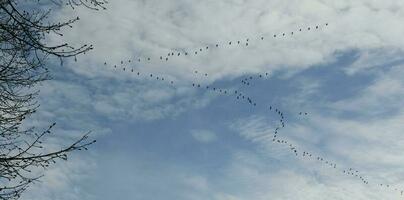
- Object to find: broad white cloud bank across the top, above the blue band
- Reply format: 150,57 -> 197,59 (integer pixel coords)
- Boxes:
48,0 -> 404,82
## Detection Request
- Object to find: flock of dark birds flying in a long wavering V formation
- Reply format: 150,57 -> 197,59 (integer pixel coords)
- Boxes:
85,23 -> 404,196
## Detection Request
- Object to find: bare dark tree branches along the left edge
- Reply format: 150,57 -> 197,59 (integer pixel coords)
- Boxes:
0,0 -> 107,199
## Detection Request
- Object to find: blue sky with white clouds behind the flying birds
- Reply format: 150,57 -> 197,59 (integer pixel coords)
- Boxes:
22,0 -> 404,200
